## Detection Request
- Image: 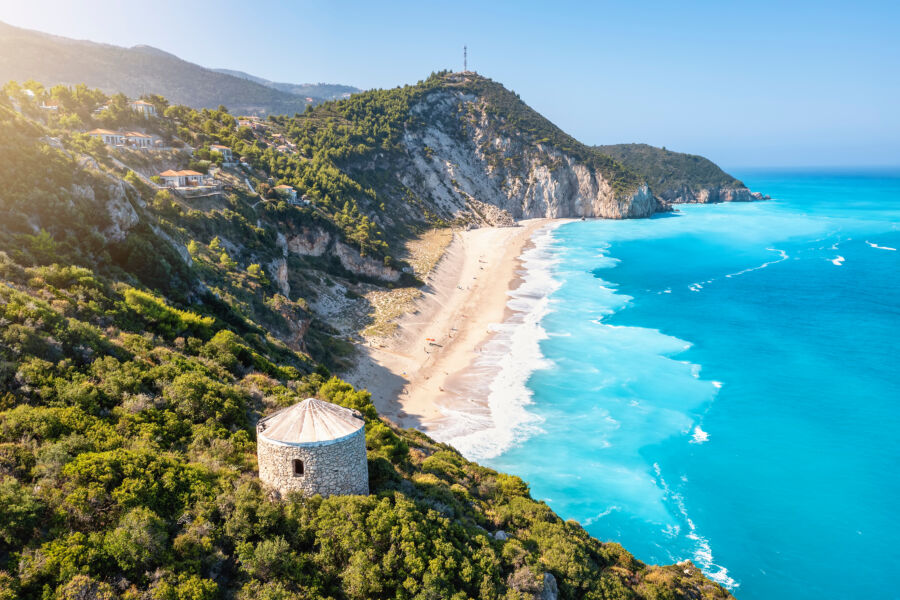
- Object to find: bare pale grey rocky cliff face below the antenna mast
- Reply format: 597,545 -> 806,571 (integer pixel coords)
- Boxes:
386,89 -> 662,225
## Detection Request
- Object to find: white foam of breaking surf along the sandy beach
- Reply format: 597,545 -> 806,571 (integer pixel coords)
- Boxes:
442,226 -> 560,460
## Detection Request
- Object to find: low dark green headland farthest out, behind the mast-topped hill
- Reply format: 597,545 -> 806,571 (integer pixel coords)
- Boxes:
594,144 -> 762,203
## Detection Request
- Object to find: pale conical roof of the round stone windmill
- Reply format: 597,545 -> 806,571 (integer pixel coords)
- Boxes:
259,398 -> 365,444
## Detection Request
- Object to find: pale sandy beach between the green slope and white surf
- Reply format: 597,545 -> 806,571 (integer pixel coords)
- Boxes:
346,219 -> 554,431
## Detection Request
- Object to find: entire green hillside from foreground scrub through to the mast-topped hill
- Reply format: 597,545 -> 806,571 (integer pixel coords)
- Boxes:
0,74 -> 744,600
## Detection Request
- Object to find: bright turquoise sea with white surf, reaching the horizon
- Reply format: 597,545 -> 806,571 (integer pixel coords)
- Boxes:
451,171 -> 900,600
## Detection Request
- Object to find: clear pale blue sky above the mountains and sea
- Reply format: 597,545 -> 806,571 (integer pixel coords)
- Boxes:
0,0 -> 900,167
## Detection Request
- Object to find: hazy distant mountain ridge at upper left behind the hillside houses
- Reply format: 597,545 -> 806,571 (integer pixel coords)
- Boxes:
0,22 -> 356,114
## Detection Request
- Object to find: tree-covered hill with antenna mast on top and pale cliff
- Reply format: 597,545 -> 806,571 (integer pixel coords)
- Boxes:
178,72 -> 660,245
